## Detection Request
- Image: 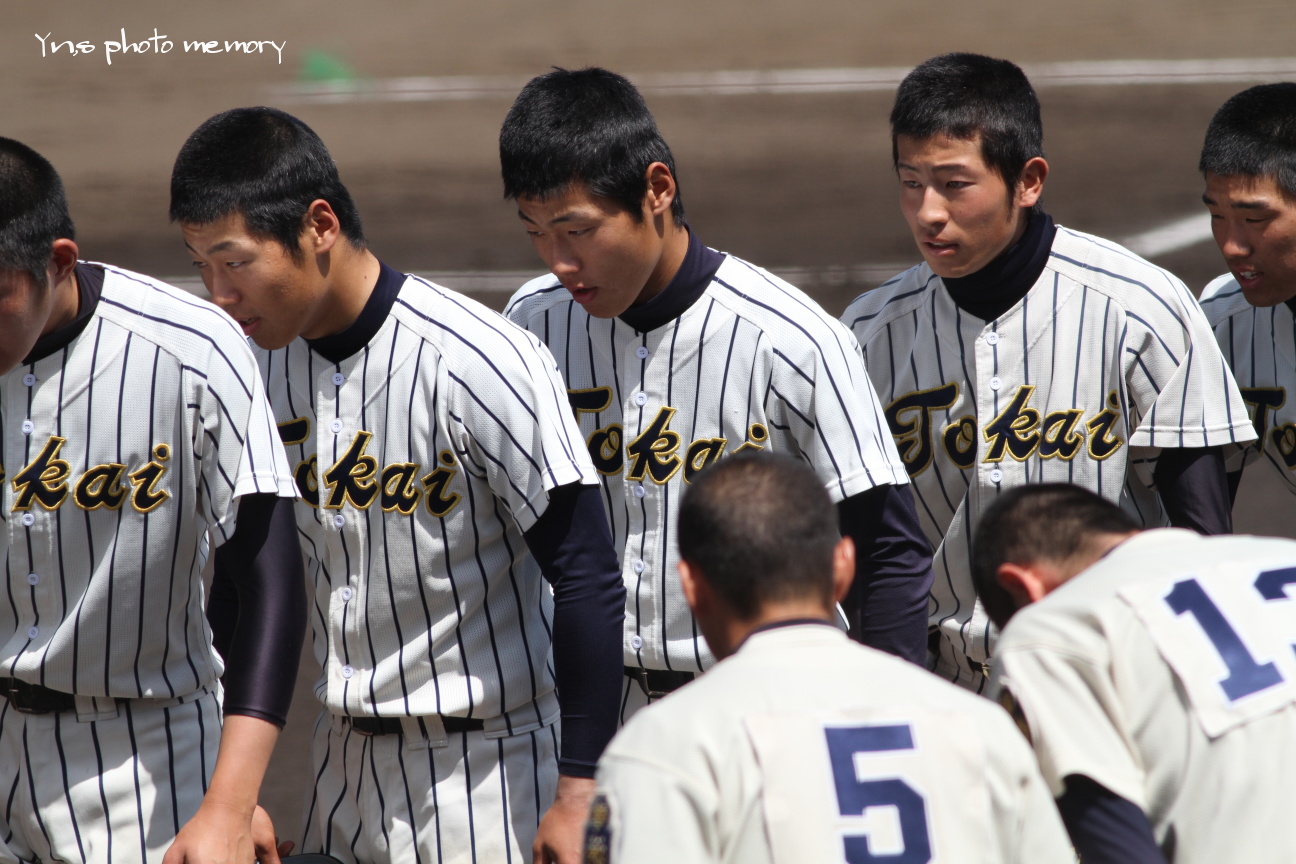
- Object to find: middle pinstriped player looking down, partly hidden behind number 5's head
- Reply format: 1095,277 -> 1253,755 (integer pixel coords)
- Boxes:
500,69 -> 931,716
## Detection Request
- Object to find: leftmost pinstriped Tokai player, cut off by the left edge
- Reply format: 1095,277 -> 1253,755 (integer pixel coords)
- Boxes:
0,139 -> 306,864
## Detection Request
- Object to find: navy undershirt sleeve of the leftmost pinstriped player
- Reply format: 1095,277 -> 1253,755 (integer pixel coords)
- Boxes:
207,495 -> 306,728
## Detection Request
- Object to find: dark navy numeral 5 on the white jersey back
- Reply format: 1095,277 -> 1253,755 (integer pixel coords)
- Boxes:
823,725 -> 932,864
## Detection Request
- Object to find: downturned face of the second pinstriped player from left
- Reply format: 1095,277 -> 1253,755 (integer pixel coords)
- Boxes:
180,214 -> 332,350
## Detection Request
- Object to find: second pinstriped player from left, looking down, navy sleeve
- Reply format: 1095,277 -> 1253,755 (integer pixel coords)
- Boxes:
171,108 -> 625,863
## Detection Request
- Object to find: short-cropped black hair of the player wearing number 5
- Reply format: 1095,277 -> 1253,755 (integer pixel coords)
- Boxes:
677,452 -> 841,620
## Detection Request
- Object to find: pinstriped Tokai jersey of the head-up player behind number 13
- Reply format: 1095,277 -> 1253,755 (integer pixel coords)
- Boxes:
842,228 -> 1255,684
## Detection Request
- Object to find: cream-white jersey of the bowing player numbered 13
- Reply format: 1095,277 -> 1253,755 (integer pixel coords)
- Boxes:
997,529 -> 1296,864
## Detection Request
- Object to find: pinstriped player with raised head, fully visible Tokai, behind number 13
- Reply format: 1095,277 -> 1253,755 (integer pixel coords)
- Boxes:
842,54 -> 1255,692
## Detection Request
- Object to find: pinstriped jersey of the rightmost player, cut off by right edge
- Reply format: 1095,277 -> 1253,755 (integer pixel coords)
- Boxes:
1201,273 -> 1296,492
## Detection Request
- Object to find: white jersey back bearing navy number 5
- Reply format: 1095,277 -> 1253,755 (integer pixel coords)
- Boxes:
586,624 -> 1074,864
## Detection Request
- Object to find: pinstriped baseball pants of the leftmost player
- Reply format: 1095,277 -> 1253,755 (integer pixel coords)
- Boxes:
0,693 -> 220,864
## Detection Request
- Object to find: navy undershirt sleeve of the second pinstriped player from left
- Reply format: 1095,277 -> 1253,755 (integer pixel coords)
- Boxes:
525,483 -> 626,777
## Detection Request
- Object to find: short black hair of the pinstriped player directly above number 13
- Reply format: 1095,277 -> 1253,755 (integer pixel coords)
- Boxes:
890,53 -> 1045,194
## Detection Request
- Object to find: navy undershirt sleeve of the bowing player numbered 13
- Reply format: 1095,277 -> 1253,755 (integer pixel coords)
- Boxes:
1058,775 -> 1166,864
